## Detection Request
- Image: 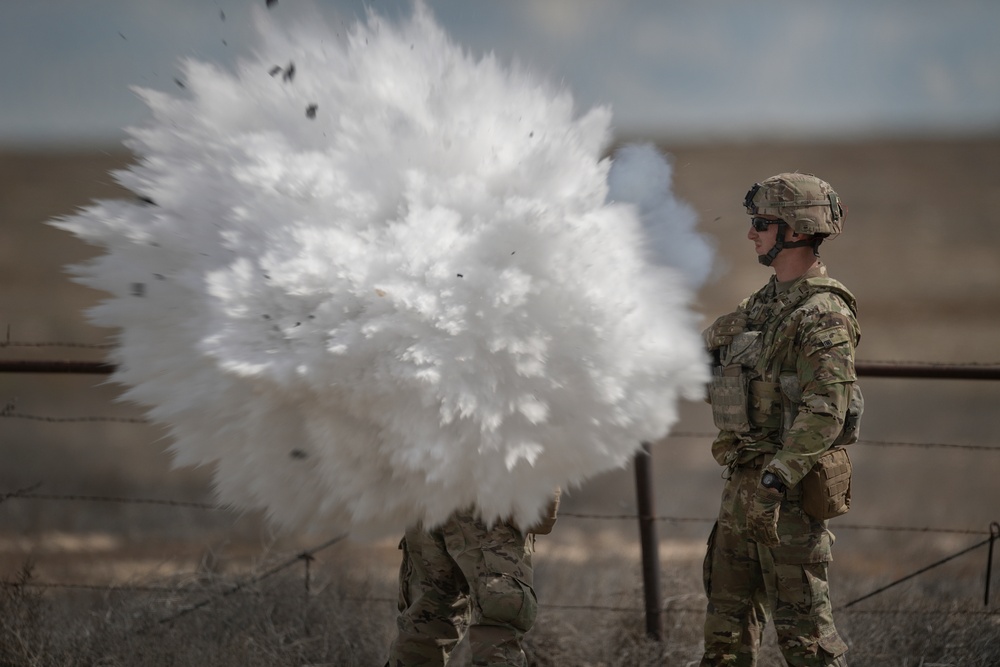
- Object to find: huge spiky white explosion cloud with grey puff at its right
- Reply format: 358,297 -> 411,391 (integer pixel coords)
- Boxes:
53,4 -> 710,536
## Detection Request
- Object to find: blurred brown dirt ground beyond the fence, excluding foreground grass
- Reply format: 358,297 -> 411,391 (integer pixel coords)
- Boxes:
0,137 -> 1000,664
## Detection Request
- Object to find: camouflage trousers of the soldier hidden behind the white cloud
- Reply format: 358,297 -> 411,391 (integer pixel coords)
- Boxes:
386,512 -> 538,667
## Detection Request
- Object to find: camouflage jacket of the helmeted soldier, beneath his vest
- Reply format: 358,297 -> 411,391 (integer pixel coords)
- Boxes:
712,264 -> 861,487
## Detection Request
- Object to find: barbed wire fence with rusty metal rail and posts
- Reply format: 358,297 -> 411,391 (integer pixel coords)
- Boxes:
0,340 -> 1000,639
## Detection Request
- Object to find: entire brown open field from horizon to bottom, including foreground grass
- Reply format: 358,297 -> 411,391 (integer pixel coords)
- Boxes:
0,137 -> 1000,667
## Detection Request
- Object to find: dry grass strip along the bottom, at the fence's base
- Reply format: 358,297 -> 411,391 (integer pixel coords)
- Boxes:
0,533 -> 1000,667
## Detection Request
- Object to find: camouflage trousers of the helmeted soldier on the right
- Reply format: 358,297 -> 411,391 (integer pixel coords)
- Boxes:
701,459 -> 847,667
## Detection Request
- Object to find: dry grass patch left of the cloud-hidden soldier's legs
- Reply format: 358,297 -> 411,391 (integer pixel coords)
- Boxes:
0,569 -> 391,667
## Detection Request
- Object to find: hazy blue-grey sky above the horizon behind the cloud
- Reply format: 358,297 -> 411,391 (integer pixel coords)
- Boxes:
0,0 -> 1000,145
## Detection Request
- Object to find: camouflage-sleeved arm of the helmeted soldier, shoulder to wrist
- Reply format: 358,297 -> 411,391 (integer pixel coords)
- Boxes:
768,302 -> 857,486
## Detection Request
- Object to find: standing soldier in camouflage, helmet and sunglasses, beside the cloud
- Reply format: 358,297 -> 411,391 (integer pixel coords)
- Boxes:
701,173 -> 861,667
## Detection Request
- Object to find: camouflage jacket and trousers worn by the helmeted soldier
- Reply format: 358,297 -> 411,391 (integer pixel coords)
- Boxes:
701,264 -> 860,667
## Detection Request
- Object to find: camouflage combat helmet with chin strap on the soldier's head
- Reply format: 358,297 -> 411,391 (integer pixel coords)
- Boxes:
743,173 -> 846,265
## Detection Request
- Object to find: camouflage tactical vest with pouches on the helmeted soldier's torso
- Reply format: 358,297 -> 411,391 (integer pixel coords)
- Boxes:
709,276 -> 864,446
